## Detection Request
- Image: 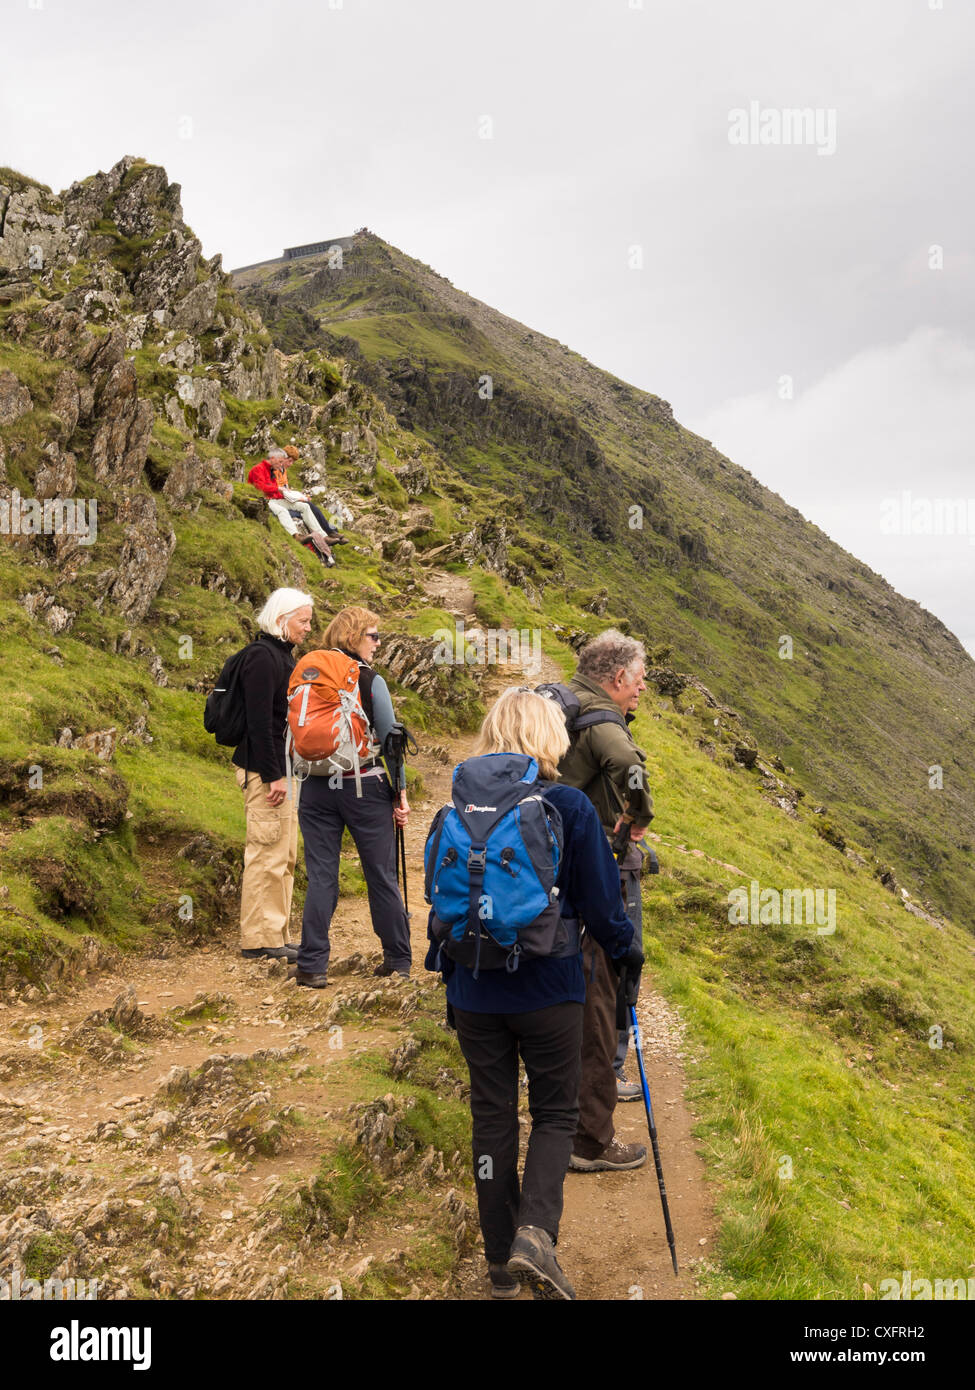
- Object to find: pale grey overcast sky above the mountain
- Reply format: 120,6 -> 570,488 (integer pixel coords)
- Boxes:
0,0 -> 975,653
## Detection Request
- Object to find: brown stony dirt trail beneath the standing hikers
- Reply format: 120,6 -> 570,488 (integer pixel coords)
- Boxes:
0,573 -> 714,1300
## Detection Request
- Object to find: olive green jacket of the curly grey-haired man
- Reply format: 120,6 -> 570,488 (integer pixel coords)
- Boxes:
559,676 -> 654,833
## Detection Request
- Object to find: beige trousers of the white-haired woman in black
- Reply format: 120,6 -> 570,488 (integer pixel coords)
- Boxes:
236,767 -> 299,951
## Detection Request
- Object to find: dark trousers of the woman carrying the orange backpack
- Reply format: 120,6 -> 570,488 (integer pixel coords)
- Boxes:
298,773 -> 412,974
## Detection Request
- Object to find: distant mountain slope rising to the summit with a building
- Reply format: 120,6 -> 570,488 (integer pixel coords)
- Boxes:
232,229 -> 975,916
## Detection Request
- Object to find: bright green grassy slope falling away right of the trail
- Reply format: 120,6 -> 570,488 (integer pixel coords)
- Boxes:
636,689 -> 975,1298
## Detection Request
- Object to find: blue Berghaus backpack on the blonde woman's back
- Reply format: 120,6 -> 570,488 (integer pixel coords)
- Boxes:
424,753 -> 580,979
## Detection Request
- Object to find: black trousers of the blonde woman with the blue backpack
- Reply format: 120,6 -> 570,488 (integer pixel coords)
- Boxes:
453,1002 -> 583,1265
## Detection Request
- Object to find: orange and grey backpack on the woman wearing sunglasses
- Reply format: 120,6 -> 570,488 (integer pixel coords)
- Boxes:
287,651 -> 380,796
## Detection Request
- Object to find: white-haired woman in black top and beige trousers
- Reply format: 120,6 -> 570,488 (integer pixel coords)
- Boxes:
231,589 -> 314,962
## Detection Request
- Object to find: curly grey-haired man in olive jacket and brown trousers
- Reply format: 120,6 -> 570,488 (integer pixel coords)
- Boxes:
559,628 -> 654,1172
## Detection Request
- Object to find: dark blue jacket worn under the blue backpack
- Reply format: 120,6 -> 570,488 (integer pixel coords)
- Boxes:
424,783 -> 633,1013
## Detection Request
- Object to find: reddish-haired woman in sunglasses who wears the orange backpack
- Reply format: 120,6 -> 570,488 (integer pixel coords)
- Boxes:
295,607 -> 412,990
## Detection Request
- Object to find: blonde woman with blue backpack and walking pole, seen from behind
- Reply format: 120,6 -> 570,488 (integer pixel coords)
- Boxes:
426,687 -> 643,1300
